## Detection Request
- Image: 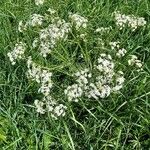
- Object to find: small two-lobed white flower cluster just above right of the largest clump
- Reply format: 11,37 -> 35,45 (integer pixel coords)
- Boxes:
109,42 -> 127,58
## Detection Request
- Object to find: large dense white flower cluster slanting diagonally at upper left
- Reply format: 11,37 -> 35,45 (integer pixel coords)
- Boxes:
39,19 -> 71,57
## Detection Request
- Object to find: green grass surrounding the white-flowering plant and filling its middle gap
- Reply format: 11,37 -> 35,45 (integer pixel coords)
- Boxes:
0,0 -> 150,150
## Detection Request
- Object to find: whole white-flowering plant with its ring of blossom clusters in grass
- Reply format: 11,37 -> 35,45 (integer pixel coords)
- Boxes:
7,0 -> 146,119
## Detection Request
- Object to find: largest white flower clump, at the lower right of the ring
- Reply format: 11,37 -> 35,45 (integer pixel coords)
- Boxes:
65,54 -> 125,102
